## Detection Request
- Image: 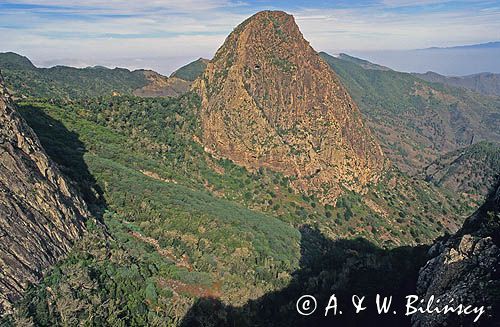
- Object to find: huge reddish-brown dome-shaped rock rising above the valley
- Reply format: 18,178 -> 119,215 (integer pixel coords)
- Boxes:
194,11 -> 384,203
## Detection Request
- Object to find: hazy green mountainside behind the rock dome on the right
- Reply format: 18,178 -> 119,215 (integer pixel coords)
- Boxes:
320,53 -> 500,173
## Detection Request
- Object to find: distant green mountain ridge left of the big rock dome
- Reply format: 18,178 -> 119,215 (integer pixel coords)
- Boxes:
0,52 -> 191,99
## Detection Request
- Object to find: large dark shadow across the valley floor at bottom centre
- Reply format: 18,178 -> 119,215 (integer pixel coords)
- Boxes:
181,227 -> 428,327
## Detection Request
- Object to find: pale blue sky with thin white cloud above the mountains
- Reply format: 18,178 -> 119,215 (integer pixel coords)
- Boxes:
0,0 -> 500,74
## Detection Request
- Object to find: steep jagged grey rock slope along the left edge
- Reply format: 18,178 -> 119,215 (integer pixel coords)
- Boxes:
0,74 -> 88,315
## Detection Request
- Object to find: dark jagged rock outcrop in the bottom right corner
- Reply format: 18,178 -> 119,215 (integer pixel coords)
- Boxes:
412,186 -> 500,326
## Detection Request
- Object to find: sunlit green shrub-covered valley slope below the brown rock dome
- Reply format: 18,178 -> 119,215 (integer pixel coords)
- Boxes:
0,94 -> 470,326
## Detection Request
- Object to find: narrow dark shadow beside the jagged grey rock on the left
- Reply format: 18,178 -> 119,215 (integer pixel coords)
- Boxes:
18,106 -> 107,222
